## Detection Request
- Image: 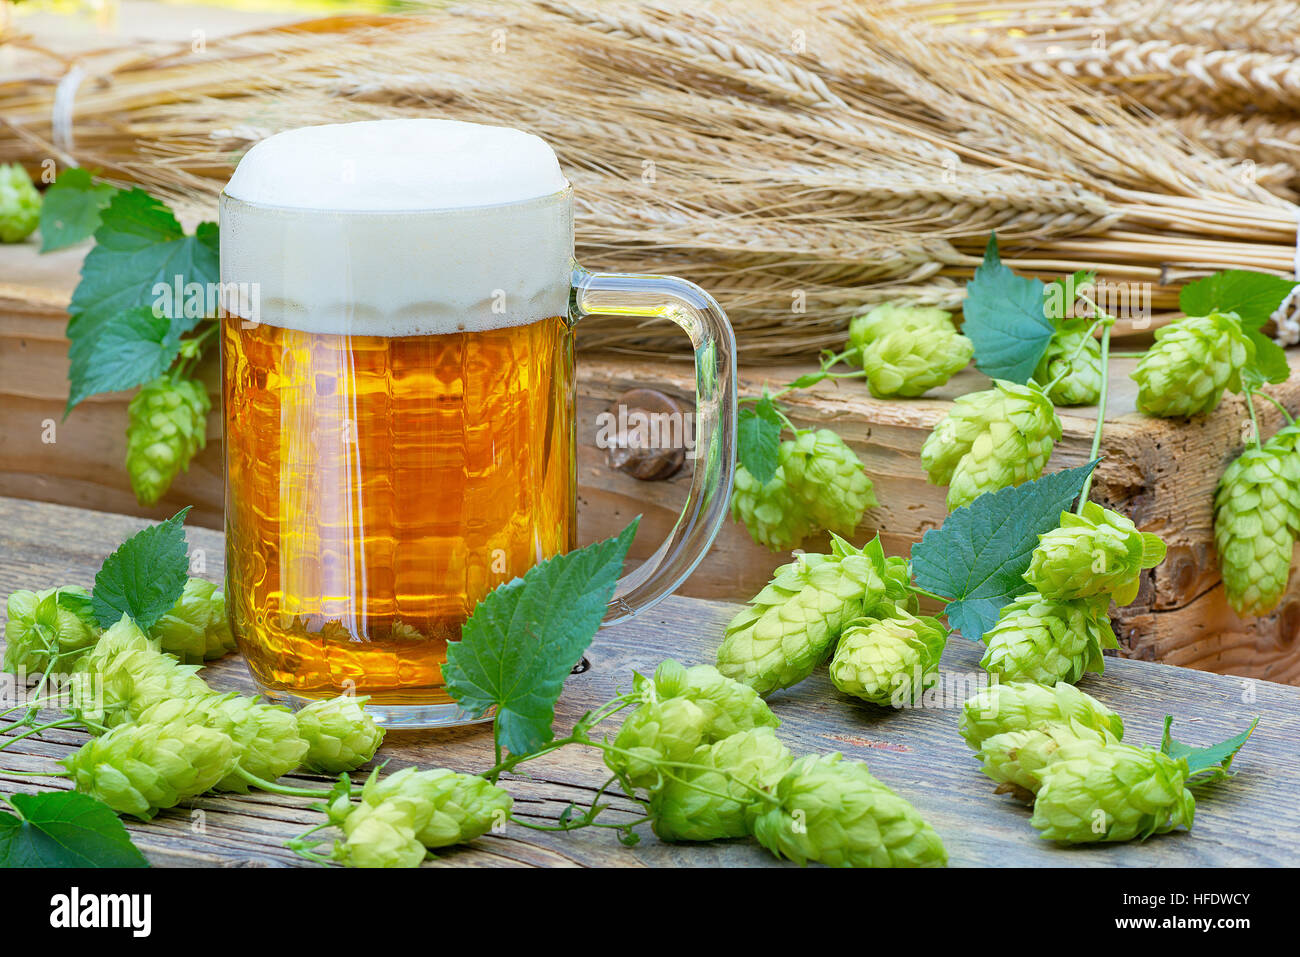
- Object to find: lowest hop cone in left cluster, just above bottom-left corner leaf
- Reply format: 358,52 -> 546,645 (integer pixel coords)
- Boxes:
64,722 -> 235,820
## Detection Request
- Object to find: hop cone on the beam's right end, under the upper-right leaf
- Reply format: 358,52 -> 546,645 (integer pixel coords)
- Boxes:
1132,312 -> 1255,417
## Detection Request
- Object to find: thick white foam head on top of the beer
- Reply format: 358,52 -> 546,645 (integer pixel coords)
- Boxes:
221,120 -> 573,335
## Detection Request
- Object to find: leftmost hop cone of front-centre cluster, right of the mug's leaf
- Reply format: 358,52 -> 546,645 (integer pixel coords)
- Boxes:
605,698 -> 718,791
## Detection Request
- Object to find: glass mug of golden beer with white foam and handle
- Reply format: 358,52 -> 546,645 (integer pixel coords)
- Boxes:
221,120 -> 736,728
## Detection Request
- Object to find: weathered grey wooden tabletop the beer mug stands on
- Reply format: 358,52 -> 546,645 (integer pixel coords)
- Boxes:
0,499 -> 1300,867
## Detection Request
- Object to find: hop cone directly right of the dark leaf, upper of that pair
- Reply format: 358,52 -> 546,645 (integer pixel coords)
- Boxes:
1024,502 -> 1165,605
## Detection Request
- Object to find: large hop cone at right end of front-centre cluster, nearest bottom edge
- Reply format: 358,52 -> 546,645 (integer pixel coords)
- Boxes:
750,753 -> 948,867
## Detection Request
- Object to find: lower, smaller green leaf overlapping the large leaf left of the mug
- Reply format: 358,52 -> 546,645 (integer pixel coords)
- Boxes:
65,306 -> 181,415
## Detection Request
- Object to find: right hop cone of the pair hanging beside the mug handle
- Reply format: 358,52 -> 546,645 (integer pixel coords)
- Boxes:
781,429 -> 876,534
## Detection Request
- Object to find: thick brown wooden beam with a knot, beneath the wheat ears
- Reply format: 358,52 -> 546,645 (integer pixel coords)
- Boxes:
0,246 -> 1300,683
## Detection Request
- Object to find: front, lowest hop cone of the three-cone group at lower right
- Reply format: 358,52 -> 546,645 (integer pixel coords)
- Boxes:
1030,744 -> 1196,844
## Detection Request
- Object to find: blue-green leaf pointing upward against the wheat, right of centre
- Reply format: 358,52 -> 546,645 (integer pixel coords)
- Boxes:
962,234 -> 1054,384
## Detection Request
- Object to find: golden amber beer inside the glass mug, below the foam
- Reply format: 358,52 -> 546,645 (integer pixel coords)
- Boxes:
221,317 -> 575,705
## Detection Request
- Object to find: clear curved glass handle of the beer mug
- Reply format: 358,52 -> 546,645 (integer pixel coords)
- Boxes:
569,264 -> 736,627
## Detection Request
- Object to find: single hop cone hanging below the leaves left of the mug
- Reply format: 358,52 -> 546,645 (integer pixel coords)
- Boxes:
126,374 -> 212,505
